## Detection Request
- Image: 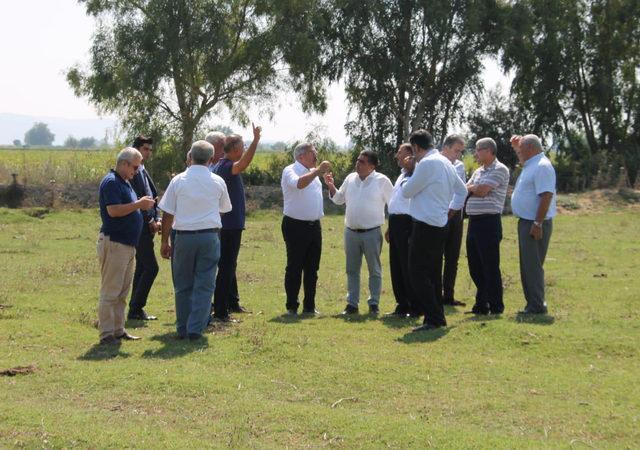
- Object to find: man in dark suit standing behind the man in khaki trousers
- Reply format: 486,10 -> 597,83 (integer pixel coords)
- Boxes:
127,135 -> 162,320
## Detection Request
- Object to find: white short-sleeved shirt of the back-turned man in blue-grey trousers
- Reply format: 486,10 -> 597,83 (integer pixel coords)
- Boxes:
158,164 -> 231,231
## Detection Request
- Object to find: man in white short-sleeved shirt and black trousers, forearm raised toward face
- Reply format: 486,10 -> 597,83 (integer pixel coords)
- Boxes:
280,142 -> 331,315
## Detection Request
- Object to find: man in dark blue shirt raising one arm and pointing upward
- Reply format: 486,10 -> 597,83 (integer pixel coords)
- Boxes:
211,124 -> 261,322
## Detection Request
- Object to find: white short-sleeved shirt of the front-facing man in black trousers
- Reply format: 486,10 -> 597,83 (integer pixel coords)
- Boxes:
280,161 -> 324,221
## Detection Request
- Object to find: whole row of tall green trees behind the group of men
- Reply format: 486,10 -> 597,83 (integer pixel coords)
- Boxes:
67,0 -> 640,185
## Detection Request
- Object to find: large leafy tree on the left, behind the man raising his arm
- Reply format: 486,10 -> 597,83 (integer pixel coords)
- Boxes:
67,0 -> 325,159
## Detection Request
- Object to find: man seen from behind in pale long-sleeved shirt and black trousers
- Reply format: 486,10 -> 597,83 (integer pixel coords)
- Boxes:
402,130 -> 467,332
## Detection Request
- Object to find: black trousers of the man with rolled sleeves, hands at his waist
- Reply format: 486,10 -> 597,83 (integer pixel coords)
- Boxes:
409,220 -> 447,326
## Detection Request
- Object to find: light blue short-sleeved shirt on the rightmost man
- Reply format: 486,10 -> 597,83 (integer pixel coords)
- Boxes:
511,152 -> 556,220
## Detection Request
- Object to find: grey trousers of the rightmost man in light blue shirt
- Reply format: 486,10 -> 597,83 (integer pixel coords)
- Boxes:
518,219 -> 553,313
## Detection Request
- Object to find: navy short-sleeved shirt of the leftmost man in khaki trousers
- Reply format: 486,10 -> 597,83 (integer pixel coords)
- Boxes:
99,170 -> 142,247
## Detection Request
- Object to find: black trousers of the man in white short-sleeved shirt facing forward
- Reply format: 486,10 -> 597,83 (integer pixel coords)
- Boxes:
282,216 -> 322,311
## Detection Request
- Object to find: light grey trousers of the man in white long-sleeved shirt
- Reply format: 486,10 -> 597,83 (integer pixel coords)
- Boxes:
344,227 -> 382,307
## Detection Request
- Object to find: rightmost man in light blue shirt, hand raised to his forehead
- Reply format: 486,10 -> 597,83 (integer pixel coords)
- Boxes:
511,134 -> 556,314
